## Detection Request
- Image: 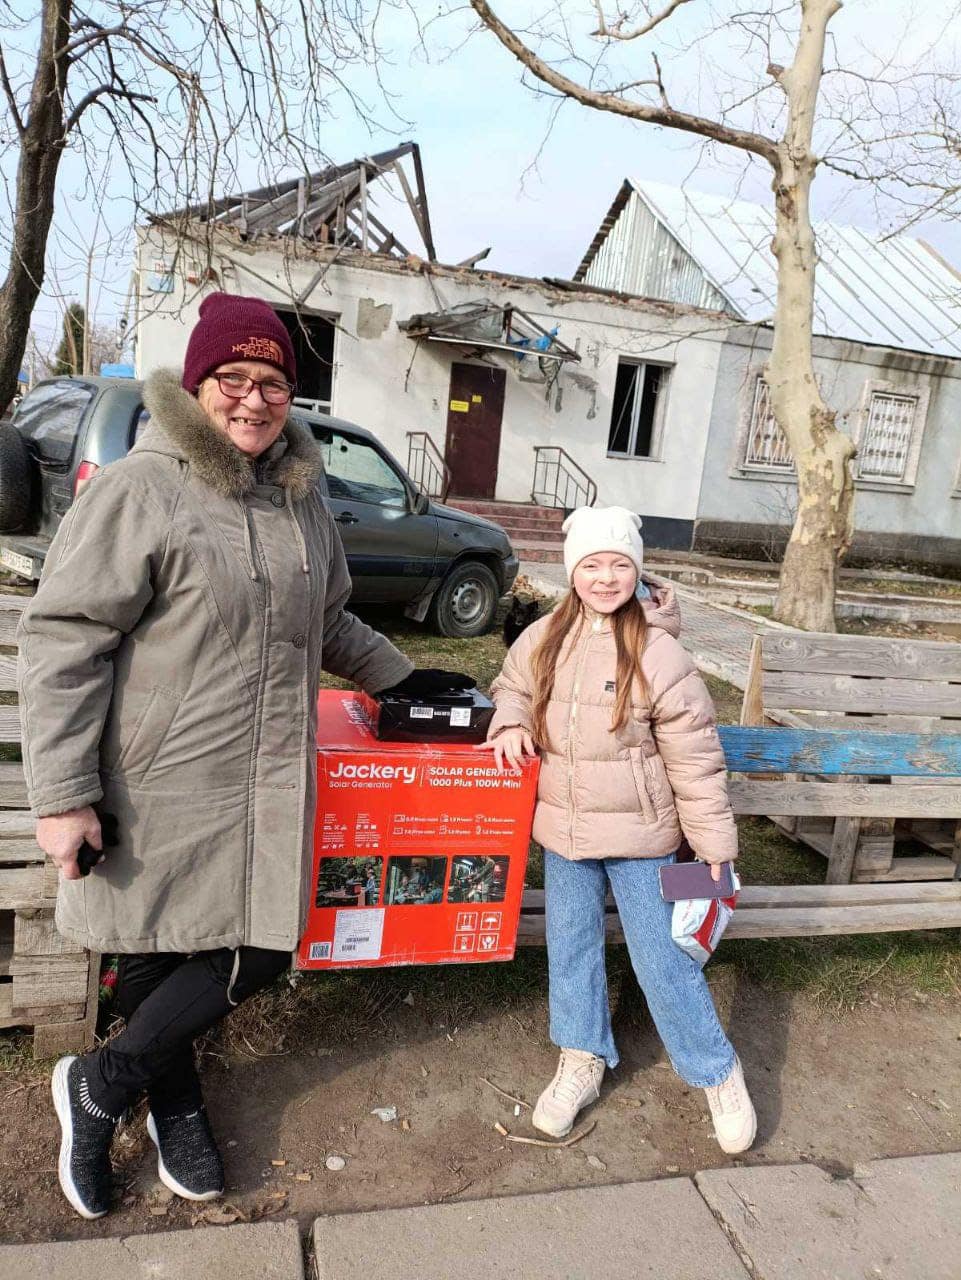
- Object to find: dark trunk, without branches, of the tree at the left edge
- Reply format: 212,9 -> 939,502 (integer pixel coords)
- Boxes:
0,0 -> 72,410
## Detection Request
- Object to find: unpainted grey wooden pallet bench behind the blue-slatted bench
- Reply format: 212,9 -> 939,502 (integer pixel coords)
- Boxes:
741,631 -> 961,882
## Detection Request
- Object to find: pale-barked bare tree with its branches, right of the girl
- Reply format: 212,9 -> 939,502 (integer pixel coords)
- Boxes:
471,0 -> 957,631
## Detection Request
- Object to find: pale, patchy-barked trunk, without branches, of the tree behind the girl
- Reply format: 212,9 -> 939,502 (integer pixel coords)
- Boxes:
766,0 -> 855,631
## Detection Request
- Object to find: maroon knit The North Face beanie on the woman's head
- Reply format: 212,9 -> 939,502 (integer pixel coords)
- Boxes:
182,293 -> 297,394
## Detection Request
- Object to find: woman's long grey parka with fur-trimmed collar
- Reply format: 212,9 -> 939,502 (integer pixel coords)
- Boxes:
18,371 -> 412,952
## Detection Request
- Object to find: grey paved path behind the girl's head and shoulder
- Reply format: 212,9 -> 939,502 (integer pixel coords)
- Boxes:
520,561 -> 791,689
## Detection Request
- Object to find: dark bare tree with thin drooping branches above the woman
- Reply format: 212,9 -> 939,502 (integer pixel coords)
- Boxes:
0,0 -> 394,414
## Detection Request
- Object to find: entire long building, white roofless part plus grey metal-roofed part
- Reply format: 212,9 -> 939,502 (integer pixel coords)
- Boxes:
134,142 -> 961,562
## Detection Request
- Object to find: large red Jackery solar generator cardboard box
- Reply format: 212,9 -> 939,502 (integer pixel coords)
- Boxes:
297,690 -> 539,969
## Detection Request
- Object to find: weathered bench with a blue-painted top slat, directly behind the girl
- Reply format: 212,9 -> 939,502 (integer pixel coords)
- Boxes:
517,726 -> 961,946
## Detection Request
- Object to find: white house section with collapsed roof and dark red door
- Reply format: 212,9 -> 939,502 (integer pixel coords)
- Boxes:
136,143 -> 731,547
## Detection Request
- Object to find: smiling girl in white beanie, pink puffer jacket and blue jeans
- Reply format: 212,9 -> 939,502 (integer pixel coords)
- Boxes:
485,507 -> 755,1153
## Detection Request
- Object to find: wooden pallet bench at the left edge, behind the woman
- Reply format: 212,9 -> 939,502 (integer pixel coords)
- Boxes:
0,595 -> 100,1057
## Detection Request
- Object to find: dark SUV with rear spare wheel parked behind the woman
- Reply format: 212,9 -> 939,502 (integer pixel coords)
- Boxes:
0,378 -> 517,636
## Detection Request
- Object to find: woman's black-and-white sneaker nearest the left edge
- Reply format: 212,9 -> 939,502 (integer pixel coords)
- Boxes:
51,1055 -> 119,1217
